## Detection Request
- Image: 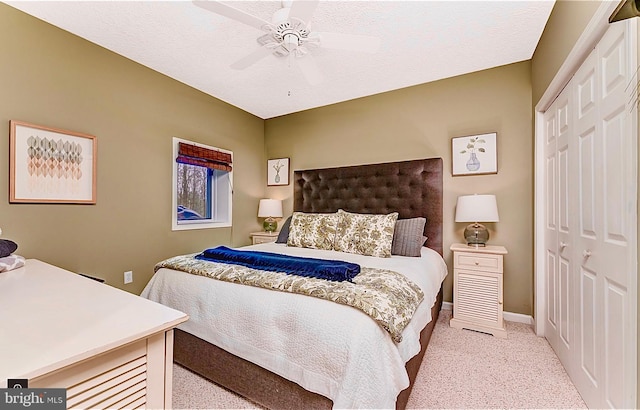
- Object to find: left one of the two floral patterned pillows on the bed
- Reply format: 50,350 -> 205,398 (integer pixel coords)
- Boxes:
287,212 -> 338,250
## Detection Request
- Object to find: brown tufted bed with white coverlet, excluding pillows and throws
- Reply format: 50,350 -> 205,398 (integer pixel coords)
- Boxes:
142,158 -> 446,409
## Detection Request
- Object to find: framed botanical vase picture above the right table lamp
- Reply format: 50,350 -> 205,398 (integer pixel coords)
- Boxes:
451,132 -> 498,177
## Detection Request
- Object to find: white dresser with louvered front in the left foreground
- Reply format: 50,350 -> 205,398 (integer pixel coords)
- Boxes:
0,259 -> 188,409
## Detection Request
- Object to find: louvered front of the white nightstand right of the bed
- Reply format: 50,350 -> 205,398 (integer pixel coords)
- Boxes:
454,270 -> 502,326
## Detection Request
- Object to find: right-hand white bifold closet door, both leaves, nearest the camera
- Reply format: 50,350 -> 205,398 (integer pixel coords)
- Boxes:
574,20 -> 637,408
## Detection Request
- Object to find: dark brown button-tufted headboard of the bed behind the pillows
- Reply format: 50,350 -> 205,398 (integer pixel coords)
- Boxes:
293,158 -> 442,255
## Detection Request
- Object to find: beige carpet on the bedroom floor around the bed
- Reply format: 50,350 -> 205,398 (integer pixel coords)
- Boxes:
173,310 -> 587,409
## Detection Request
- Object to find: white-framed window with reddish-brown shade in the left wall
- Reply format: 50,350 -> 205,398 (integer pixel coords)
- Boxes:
172,138 -> 233,231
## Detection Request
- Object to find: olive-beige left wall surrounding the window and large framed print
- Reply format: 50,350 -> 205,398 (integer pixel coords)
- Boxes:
0,4 -> 266,293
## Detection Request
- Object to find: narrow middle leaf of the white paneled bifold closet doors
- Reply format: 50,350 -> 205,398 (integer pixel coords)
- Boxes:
570,40 -> 603,408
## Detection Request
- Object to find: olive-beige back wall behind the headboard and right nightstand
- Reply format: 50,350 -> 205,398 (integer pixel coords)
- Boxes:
265,62 -> 533,315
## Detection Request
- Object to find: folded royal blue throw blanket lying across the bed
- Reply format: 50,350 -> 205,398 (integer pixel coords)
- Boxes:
195,246 -> 360,282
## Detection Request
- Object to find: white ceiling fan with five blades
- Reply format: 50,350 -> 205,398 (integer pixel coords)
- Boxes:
193,0 -> 380,85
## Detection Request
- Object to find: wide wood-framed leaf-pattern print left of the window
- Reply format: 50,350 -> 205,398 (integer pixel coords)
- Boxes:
9,120 -> 97,204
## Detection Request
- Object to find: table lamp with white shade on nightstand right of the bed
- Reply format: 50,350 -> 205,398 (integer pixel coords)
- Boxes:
456,194 -> 500,246
